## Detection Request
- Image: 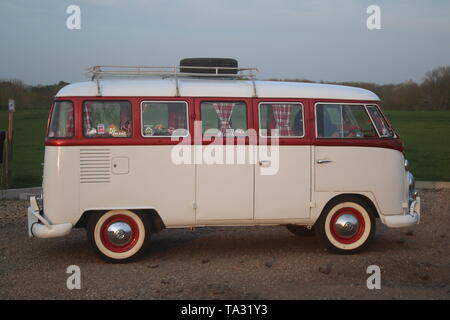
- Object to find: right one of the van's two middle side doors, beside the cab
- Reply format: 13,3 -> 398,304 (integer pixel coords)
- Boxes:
254,99 -> 311,223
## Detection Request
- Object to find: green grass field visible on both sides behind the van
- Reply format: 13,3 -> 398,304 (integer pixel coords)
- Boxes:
0,109 -> 450,188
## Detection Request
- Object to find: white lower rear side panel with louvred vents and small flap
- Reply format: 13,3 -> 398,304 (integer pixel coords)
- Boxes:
43,146 -> 195,227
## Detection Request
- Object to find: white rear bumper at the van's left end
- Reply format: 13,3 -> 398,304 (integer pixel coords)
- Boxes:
28,197 -> 73,238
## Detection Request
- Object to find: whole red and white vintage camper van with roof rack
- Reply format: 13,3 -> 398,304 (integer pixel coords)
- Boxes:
28,60 -> 420,261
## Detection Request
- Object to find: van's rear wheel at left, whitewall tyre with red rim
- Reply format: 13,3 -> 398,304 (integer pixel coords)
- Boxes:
87,210 -> 151,262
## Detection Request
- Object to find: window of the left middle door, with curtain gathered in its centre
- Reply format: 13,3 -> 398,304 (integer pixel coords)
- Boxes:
200,101 -> 248,137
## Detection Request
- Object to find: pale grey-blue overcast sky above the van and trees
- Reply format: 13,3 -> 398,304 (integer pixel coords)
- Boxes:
0,0 -> 450,84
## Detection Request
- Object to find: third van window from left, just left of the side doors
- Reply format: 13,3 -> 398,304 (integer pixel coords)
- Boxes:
141,101 -> 189,137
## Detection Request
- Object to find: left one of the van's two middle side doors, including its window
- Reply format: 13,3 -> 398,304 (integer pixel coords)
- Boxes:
195,98 -> 254,225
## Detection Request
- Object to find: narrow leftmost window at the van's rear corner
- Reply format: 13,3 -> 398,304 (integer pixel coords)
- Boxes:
48,101 -> 74,138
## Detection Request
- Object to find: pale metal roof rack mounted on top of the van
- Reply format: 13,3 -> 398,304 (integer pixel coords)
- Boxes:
87,65 -> 259,96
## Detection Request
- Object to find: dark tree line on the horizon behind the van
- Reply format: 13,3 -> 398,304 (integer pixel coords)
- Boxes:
0,66 -> 450,110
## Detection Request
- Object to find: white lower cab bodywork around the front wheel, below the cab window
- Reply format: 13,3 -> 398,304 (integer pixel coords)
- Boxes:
314,146 -> 408,215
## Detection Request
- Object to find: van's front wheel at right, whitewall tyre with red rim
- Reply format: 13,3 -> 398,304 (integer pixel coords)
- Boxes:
315,197 -> 376,254
